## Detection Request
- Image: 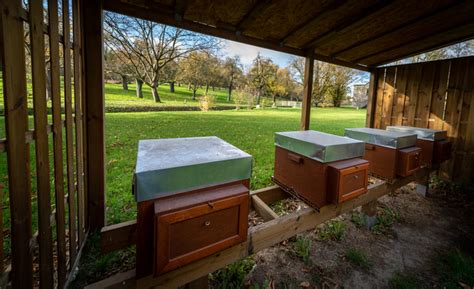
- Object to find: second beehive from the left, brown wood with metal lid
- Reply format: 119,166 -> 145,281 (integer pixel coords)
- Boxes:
273,130 -> 369,209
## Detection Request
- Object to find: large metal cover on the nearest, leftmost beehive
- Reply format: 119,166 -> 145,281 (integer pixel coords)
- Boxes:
134,136 -> 252,202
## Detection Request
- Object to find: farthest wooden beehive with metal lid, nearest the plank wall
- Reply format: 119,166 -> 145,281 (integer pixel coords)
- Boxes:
386,126 -> 451,168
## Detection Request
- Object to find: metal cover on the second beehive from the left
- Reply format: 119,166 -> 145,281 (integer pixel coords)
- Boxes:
275,130 -> 365,163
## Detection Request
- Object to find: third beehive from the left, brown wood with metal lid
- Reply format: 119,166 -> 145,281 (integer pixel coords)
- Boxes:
345,128 -> 421,181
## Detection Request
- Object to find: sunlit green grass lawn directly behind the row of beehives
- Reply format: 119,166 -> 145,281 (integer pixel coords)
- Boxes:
105,108 -> 365,223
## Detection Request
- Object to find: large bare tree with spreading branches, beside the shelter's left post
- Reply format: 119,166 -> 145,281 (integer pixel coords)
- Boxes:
104,12 -> 219,102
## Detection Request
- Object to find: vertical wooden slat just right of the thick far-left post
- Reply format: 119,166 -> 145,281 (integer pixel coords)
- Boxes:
29,1 -> 54,288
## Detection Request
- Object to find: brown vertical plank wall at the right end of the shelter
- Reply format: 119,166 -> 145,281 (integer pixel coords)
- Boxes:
367,57 -> 474,182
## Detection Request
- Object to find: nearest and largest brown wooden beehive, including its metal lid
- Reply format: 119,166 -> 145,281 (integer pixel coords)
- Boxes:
134,137 -> 252,278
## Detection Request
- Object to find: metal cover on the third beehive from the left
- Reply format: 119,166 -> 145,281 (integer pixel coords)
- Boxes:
344,127 -> 416,149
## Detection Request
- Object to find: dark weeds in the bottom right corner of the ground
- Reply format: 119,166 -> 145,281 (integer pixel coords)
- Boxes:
437,249 -> 474,288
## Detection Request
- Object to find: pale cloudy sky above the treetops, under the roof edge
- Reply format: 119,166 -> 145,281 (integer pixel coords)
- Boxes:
222,40 -> 294,67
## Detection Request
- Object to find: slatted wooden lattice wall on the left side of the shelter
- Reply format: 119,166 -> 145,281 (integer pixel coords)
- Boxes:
0,0 -> 88,289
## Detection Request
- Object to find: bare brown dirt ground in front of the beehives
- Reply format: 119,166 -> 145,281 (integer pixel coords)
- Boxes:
246,180 -> 474,288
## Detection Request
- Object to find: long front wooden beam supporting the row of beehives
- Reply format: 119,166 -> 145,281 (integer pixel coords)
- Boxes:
85,168 -> 431,289
